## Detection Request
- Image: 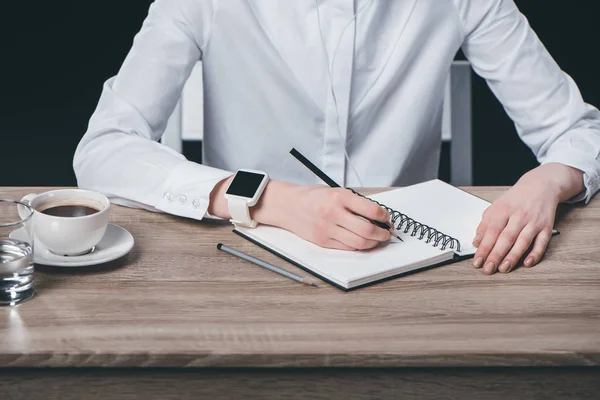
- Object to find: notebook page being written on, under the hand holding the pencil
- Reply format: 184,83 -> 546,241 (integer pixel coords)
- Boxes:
236,225 -> 453,288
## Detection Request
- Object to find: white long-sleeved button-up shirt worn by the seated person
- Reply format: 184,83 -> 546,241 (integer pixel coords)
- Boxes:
74,0 -> 600,219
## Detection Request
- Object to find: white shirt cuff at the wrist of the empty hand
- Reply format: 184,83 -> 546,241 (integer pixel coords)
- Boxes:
542,149 -> 600,204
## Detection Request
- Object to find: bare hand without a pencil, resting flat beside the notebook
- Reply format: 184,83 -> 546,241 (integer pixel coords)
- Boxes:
473,163 -> 584,275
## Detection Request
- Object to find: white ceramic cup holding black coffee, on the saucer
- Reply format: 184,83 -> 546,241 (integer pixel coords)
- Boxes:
21,189 -> 110,256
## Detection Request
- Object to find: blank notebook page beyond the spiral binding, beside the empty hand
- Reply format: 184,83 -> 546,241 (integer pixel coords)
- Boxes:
369,179 -> 491,255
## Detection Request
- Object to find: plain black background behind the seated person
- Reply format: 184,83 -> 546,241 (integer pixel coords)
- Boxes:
0,0 -> 600,186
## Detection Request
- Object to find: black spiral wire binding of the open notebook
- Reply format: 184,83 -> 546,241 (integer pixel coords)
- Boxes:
350,189 -> 460,251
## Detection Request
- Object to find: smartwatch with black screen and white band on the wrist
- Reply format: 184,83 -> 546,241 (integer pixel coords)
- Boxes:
225,169 -> 269,228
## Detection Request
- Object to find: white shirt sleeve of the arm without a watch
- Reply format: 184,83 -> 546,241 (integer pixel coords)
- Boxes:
455,0 -> 600,203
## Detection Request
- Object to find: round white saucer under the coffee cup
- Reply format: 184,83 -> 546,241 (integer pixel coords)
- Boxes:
10,224 -> 133,267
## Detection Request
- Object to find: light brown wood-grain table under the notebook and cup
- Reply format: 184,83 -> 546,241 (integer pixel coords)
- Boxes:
0,188 -> 600,399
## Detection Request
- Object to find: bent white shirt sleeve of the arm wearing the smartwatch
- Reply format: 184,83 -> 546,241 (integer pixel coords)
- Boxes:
73,0 -> 232,219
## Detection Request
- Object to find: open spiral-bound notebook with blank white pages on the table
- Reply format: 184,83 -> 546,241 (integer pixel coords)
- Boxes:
235,180 -> 490,290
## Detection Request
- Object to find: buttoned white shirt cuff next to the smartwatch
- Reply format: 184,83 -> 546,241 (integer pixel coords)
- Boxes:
154,161 -> 233,220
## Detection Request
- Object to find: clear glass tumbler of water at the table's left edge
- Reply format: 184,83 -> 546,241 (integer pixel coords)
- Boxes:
0,200 -> 34,306
